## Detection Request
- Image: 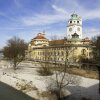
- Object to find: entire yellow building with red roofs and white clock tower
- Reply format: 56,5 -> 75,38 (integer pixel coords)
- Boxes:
27,13 -> 93,63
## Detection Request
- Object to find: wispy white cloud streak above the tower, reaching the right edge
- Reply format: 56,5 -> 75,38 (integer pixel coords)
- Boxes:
53,0 -> 100,20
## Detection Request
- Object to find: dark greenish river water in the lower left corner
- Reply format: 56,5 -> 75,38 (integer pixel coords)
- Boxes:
0,82 -> 35,100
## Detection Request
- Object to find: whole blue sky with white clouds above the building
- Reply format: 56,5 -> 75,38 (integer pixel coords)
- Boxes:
0,0 -> 100,48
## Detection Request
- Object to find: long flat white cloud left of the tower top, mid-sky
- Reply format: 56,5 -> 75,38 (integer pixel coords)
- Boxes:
21,14 -> 66,26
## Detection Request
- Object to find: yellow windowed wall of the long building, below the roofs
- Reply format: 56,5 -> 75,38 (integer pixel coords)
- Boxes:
28,46 -> 92,62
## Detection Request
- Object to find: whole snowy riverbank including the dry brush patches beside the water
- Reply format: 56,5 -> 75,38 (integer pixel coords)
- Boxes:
0,61 -> 100,100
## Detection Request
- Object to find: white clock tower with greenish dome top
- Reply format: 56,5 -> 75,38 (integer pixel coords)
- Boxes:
67,13 -> 82,39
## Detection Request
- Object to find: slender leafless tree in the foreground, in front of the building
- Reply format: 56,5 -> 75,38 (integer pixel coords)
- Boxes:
55,47 -> 80,100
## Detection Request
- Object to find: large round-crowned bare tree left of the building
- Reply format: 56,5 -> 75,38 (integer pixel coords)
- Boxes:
3,37 -> 27,70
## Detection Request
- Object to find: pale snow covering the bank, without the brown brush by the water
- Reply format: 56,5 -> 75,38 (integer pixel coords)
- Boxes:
0,60 -> 100,100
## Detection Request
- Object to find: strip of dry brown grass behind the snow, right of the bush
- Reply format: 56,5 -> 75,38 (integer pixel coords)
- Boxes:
51,66 -> 99,79
